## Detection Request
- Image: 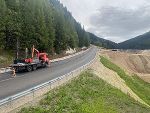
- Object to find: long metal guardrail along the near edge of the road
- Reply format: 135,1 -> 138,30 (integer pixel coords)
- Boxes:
0,48 -> 97,112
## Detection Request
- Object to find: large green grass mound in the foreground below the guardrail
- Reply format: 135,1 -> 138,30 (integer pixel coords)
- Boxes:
19,72 -> 150,113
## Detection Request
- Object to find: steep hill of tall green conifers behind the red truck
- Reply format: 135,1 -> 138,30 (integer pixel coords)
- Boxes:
0,0 -> 90,53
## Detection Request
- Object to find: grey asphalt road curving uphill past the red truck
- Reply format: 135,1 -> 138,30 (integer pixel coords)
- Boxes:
0,47 -> 97,100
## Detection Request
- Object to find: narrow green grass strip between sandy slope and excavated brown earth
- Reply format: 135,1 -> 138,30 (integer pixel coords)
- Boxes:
100,56 -> 150,105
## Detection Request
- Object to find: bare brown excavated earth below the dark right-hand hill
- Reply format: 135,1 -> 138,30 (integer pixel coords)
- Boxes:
101,50 -> 150,83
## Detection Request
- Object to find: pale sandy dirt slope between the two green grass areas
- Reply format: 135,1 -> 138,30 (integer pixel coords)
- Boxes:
91,54 -> 149,106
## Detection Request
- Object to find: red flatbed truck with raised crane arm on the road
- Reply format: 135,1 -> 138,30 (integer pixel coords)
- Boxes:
10,46 -> 50,72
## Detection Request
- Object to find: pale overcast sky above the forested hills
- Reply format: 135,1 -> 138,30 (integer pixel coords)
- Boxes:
60,0 -> 150,43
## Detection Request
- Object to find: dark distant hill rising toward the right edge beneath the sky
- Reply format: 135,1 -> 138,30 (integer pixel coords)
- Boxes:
118,32 -> 150,49
